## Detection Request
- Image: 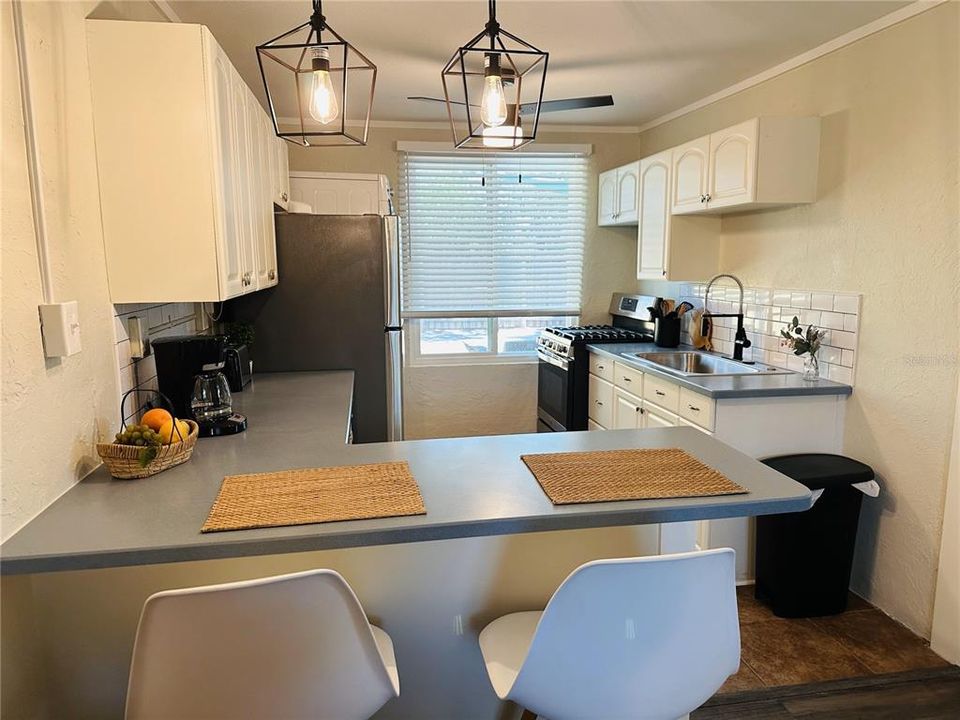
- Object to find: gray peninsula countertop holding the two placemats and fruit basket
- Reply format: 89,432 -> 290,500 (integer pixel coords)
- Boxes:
0,372 -> 812,574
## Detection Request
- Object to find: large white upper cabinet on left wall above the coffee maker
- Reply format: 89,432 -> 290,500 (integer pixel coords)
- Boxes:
87,20 -> 280,303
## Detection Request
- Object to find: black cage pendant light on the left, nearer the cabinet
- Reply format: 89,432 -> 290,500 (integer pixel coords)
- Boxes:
257,0 -> 377,147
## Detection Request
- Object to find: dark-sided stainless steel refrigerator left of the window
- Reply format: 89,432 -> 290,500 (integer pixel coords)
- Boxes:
224,213 -> 403,442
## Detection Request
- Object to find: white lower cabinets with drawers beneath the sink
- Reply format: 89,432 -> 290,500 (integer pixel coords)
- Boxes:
587,353 -> 846,581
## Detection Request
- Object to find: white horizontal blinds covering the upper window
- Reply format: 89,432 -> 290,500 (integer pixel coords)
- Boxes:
398,151 -> 589,317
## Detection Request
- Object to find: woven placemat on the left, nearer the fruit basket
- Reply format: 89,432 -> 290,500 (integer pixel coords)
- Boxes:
201,462 -> 427,533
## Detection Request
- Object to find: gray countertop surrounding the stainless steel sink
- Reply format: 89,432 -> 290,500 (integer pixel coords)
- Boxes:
587,343 -> 853,399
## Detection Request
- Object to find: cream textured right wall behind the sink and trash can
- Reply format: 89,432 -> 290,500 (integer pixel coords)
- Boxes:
640,3 -> 960,637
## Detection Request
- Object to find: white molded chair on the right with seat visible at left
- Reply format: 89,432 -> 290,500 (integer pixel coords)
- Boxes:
480,548 -> 740,720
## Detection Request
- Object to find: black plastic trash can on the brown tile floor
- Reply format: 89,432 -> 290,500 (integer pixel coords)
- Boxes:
756,453 -> 874,618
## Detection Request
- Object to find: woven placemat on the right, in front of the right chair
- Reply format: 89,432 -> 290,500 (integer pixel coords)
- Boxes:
521,448 -> 747,505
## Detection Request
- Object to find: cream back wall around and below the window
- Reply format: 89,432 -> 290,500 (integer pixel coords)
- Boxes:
290,128 -> 637,438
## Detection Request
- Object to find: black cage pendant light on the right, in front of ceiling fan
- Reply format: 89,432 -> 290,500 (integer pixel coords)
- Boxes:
441,0 -> 549,150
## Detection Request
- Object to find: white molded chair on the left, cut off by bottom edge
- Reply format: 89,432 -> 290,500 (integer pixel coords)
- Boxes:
126,570 -> 397,720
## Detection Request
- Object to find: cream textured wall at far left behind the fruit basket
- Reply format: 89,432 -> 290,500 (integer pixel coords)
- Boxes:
0,2 -> 117,539
